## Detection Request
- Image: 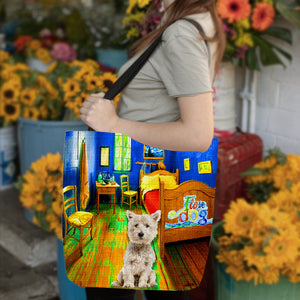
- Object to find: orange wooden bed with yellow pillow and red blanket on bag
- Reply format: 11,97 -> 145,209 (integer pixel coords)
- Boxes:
140,169 -> 215,258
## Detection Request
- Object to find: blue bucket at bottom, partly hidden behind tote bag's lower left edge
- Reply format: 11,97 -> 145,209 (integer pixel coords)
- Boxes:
57,240 -> 86,300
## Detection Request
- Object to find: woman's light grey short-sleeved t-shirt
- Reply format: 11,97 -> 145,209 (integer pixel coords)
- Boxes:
117,12 -> 216,123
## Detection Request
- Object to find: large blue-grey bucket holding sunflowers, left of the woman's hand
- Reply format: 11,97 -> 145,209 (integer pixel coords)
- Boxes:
17,118 -> 88,174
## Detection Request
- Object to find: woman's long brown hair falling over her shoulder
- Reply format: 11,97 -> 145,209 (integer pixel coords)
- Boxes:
132,0 -> 226,70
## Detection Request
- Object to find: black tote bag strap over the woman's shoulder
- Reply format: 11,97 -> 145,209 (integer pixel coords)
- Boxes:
89,18 -> 210,131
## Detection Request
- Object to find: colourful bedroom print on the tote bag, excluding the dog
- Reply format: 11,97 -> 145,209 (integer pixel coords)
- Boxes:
62,131 -> 218,290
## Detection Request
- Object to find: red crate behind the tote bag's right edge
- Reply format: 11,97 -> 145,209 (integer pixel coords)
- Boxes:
214,132 -> 263,222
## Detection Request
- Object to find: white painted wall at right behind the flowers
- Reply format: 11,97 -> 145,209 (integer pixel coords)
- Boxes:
237,21 -> 300,154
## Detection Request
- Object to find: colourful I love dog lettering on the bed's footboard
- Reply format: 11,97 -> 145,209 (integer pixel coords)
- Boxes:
168,195 -> 208,225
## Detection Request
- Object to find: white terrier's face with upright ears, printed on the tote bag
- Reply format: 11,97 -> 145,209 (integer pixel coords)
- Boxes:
127,210 -> 161,244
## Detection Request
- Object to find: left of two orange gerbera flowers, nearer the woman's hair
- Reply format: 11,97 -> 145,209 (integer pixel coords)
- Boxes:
217,0 -> 251,23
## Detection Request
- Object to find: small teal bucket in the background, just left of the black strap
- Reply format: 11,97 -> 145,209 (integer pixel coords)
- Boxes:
97,49 -> 128,70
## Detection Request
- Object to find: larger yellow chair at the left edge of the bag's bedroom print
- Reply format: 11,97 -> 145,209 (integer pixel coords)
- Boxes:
63,185 -> 94,255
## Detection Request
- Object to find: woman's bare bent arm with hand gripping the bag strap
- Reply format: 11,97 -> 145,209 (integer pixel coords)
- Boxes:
80,92 -> 214,152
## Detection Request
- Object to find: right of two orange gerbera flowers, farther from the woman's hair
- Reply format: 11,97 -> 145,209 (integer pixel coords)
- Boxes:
251,2 -> 275,31
